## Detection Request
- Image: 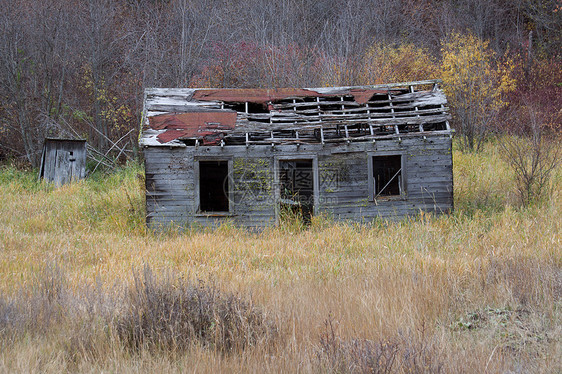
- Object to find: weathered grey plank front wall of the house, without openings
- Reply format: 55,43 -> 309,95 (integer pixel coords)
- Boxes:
144,135 -> 453,229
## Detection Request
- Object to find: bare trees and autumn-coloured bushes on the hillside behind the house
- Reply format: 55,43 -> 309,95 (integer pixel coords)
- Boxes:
0,0 -> 562,167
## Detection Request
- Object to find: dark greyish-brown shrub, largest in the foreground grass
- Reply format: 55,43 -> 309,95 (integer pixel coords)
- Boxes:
117,267 -> 274,352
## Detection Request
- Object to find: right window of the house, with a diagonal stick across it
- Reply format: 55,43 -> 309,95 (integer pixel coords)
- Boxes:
370,155 -> 404,199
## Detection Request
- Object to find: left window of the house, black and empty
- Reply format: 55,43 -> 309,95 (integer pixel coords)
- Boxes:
199,160 -> 230,213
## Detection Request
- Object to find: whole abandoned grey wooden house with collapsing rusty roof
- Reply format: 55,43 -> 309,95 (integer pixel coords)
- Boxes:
140,80 -> 453,228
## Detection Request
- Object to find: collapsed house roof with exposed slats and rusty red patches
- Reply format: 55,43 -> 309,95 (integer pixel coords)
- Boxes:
141,80 -> 450,147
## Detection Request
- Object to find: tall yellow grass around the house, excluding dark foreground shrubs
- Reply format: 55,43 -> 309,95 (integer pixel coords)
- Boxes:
0,143 -> 562,373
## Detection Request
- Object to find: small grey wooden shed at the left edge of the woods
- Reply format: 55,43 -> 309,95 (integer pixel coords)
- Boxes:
39,138 -> 86,187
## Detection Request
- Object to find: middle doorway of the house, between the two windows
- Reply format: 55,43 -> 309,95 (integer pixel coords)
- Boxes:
279,160 -> 314,222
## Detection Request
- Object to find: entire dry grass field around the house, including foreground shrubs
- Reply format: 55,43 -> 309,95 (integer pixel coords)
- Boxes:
0,143 -> 562,373
